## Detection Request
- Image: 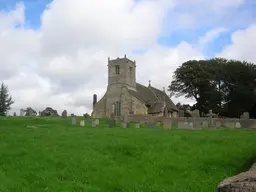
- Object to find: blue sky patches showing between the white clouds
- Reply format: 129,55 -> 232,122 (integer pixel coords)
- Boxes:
0,0 -> 256,57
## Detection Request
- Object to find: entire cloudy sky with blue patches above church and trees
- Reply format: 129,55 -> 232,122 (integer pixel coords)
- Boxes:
0,0 -> 256,115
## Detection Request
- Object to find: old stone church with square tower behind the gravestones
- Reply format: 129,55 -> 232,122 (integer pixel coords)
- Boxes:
92,55 -> 178,118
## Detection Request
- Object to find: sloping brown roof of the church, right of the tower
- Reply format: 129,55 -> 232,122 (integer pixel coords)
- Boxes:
129,83 -> 178,113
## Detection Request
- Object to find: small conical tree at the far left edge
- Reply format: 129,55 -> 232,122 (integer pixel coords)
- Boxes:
0,83 -> 14,116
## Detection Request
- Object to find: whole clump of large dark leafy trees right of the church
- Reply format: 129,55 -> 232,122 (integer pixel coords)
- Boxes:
169,58 -> 256,117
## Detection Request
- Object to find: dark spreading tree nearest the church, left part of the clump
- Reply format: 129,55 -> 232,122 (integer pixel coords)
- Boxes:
168,60 -> 215,112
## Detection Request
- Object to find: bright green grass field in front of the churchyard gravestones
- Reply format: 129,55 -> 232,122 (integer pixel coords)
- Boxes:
0,117 -> 256,192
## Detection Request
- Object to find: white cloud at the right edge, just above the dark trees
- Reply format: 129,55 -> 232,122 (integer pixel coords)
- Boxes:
217,24 -> 256,63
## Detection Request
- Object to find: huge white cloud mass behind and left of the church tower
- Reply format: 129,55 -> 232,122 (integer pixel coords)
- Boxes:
0,0 -> 254,114
